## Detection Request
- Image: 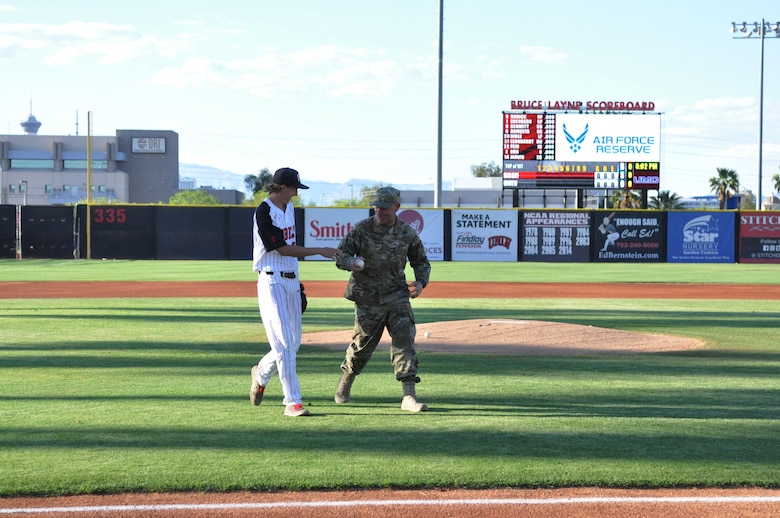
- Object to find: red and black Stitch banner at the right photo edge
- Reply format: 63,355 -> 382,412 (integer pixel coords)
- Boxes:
739,211 -> 780,263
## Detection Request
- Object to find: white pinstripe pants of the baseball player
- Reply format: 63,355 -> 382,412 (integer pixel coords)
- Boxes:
257,272 -> 302,406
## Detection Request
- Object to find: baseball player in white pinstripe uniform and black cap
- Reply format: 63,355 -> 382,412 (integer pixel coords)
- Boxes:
249,167 -> 341,417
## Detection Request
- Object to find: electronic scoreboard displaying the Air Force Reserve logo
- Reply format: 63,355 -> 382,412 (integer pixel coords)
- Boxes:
502,111 -> 661,189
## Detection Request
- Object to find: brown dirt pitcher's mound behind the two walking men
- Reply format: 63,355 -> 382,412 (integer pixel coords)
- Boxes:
302,319 -> 703,354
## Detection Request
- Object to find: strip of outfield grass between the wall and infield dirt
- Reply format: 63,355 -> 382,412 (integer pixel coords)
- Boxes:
0,259 -> 780,284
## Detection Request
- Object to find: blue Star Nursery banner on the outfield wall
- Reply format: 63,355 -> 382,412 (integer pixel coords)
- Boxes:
666,211 -> 735,263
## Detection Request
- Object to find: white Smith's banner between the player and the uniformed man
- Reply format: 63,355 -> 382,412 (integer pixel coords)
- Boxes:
298,208 -> 369,261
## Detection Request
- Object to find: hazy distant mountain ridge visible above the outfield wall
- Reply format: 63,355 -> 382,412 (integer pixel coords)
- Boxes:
179,164 -> 450,206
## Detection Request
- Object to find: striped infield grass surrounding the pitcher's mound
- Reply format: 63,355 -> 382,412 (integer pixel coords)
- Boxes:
0,265 -> 780,496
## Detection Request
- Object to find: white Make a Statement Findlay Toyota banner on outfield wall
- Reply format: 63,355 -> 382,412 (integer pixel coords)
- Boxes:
452,209 -> 519,262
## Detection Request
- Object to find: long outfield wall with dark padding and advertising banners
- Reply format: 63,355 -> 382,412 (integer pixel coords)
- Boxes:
0,205 -> 780,263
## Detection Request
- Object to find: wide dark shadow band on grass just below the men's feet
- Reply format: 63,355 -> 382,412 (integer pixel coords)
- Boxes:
0,422 -> 780,465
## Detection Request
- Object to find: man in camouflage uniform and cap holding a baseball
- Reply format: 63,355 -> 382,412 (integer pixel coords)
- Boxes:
334,187 -> 431,412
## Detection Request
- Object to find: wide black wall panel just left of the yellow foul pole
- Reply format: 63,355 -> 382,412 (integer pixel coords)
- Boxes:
21,205 -> 75,259
